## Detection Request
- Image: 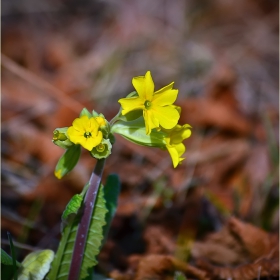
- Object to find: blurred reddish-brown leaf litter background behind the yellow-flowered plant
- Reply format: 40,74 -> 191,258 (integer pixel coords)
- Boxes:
1,0 -> 279,279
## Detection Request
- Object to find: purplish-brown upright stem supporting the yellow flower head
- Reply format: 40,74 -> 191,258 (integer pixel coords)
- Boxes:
68,159 -> 105,280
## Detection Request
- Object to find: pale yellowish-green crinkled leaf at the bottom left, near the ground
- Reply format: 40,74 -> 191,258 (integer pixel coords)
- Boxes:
18,250 -> 54,280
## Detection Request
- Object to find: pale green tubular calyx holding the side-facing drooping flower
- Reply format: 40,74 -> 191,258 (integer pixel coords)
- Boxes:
111,117 -> 168,149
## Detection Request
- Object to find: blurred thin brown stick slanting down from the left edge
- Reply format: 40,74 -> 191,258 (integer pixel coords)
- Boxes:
1,54 -> 83,113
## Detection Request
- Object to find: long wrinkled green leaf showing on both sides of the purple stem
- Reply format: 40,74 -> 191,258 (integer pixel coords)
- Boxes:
47,187 -> 107,280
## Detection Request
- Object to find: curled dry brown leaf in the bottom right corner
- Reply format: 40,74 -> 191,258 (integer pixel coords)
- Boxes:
192,217 -> 279,280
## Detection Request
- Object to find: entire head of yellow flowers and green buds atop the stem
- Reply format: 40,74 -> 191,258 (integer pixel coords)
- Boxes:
53,71 -> 191,178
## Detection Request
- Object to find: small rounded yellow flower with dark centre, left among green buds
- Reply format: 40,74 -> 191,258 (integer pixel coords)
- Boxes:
67,116 -> 103,151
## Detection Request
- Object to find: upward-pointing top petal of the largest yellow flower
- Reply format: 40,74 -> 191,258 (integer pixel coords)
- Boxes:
132,71 -> 155,102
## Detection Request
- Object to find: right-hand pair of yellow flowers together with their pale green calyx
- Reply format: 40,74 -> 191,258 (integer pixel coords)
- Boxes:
115,71 -> 191,167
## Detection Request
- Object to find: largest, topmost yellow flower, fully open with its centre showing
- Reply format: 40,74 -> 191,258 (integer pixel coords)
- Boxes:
119,71 -> 180,134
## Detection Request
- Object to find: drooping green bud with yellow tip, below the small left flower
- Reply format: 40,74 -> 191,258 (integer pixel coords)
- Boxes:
54,145 -> 81,179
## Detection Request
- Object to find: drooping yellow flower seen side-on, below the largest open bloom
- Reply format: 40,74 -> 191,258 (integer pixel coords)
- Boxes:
165,124 -> 191,168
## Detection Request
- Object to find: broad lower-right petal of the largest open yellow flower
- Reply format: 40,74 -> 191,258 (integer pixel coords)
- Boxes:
153,106 -> 180,129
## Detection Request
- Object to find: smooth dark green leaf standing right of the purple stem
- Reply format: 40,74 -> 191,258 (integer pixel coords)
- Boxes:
103,174 -> 121,243
